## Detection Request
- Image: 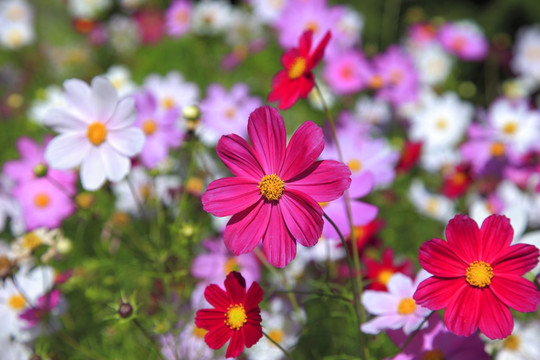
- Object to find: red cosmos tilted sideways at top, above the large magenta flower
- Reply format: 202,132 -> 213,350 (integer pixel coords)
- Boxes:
268,30 -> 331,109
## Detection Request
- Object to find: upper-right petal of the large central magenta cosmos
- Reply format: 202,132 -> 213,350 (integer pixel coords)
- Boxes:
279,121 -> 324,181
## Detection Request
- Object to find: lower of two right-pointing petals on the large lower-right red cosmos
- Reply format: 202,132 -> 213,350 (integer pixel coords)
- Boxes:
489,274 -> 540,312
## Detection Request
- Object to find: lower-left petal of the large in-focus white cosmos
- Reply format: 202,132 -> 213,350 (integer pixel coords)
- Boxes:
45,133 -> 92,170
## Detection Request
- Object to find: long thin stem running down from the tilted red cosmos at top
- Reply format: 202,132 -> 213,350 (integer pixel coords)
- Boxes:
315,82 -> 369,360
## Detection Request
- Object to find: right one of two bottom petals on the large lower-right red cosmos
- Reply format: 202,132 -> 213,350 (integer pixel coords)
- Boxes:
479,291 -> 514,339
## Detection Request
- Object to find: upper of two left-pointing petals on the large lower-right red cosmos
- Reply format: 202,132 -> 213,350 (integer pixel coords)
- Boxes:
418,239 -> 469,278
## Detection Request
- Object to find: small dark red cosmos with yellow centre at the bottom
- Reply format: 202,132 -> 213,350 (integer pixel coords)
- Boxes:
195,271 -> 263,357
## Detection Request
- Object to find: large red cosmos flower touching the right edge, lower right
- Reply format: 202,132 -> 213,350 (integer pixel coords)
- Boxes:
413,215 -> 540,339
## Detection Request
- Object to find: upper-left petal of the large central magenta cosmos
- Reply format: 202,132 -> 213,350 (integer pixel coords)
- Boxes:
216,134 -> 265,181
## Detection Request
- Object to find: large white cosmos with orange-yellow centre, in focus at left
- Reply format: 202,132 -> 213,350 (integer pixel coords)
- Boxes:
45,76 -> 145,190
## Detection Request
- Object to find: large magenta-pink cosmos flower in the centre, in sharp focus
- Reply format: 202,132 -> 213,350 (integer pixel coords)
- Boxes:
202,106 -> 351,267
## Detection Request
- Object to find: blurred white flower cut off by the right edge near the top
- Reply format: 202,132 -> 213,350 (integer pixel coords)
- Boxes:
512,25 -> 540,84
